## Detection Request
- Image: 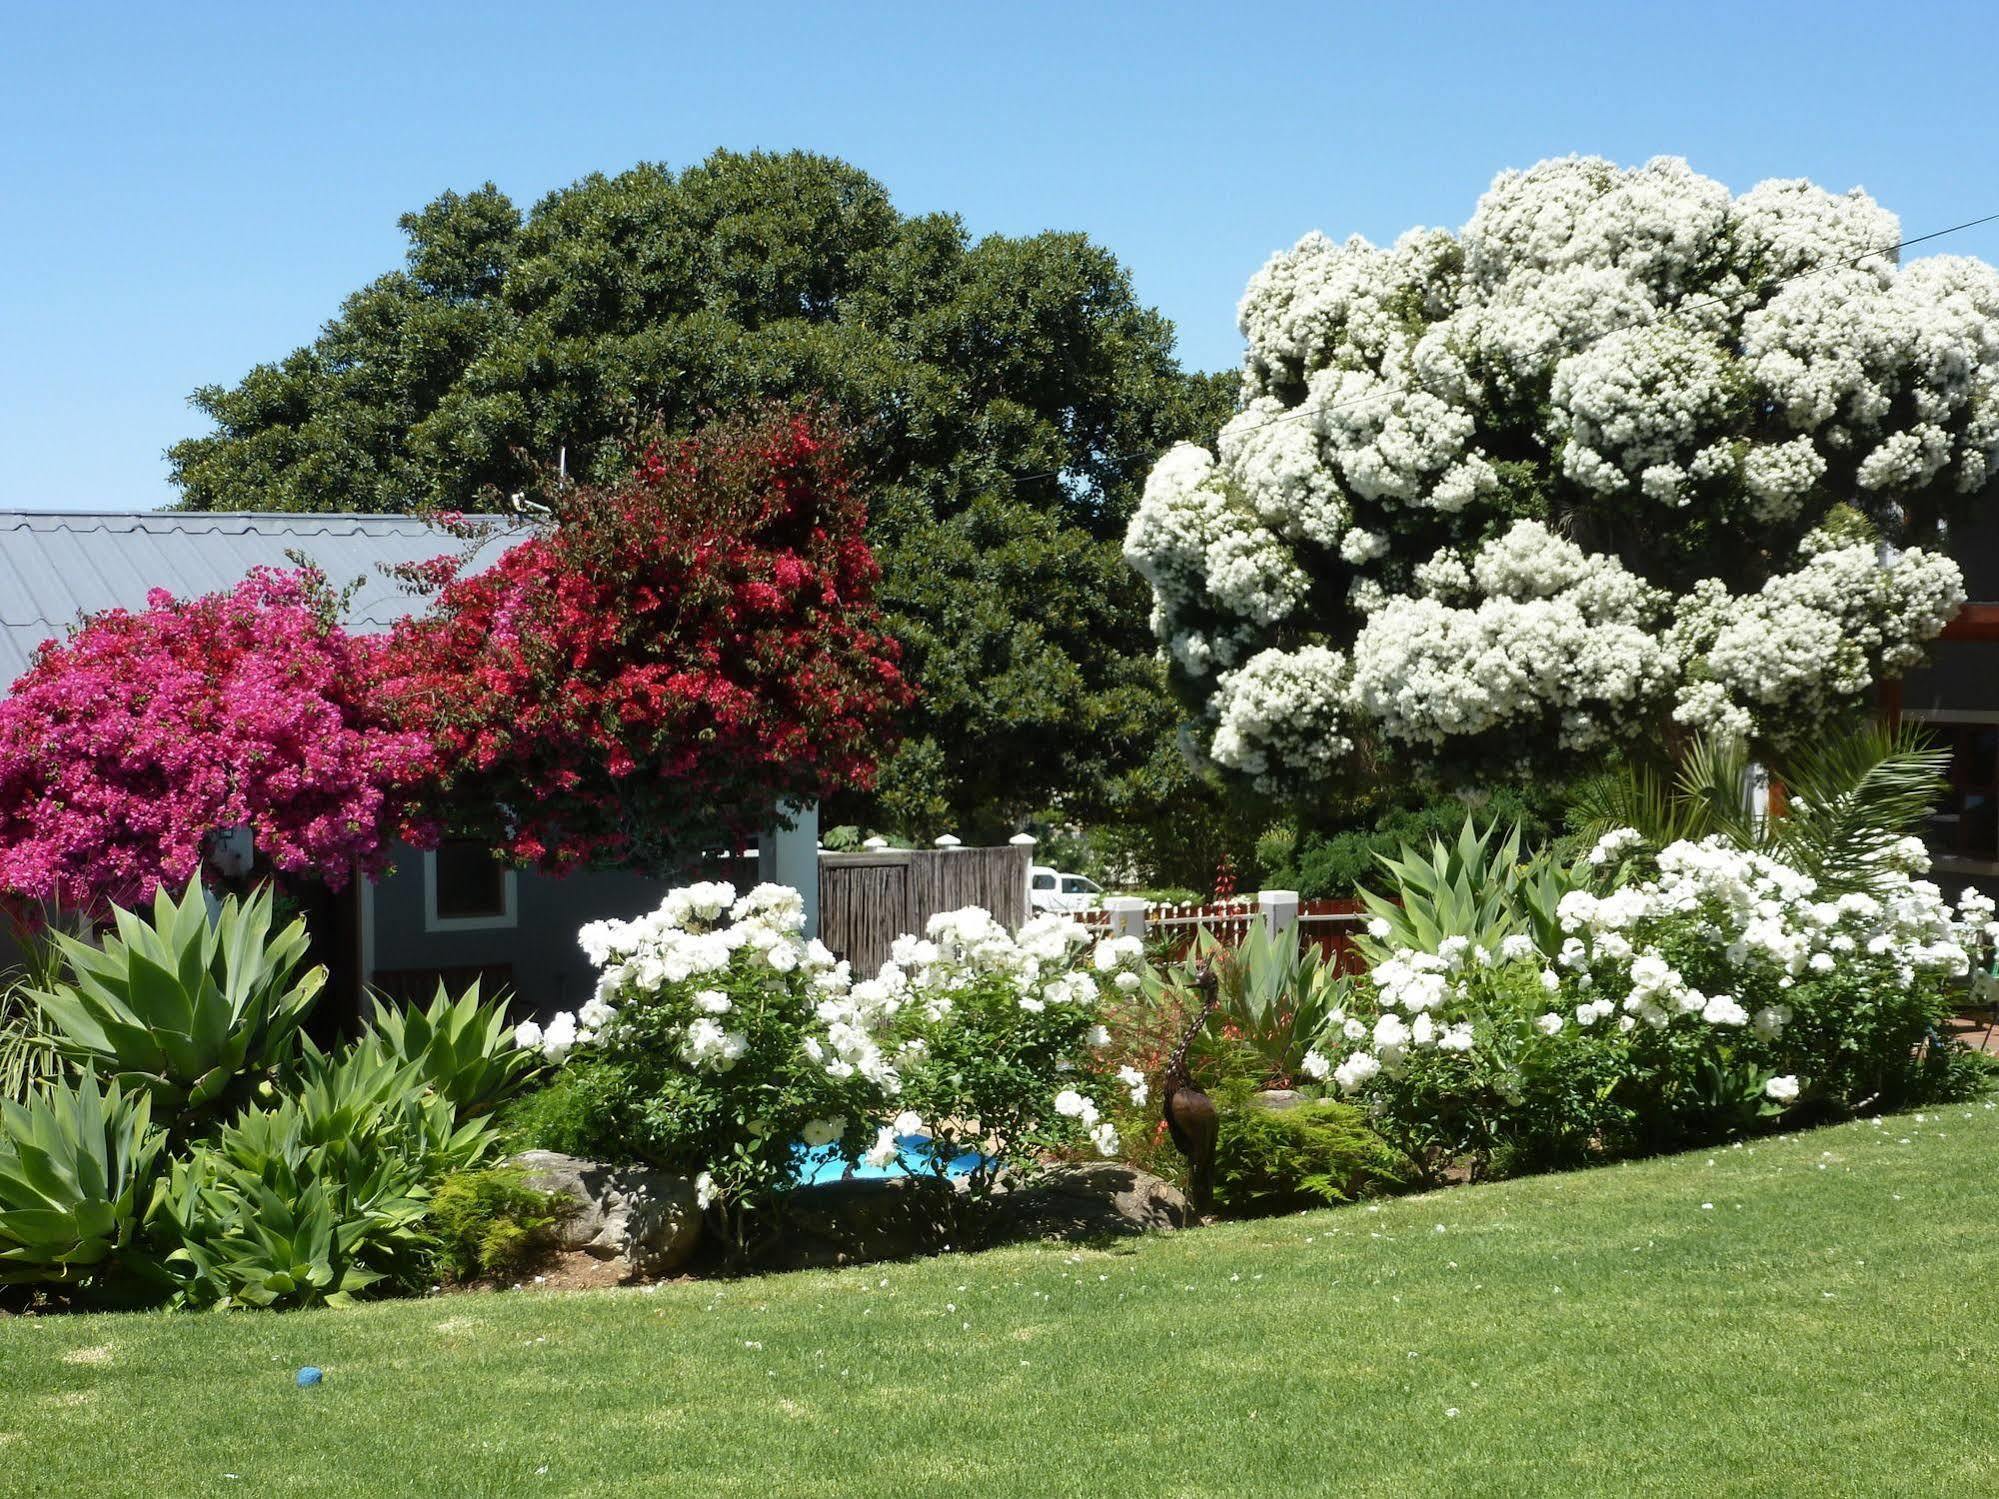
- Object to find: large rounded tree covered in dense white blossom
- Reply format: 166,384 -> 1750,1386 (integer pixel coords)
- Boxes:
1125,158 -> 1999,791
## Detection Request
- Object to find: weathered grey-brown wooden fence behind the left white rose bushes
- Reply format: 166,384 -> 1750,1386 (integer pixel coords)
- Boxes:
820,847 -> 1031,975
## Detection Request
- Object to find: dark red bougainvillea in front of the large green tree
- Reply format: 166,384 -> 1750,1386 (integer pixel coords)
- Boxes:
376,414 -> 910,869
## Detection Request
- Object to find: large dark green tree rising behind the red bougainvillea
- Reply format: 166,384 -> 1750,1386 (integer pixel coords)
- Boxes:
168,152 -> 1235,831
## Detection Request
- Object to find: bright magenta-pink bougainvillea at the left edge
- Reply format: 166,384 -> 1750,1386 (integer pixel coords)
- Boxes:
0,570 -> 432,911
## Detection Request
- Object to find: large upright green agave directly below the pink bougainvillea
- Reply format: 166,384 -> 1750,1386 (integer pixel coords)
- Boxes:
34,881 -> 326,1127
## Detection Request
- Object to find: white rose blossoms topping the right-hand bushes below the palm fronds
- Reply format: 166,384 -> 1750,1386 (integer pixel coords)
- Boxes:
1315,829 -> 1999,1101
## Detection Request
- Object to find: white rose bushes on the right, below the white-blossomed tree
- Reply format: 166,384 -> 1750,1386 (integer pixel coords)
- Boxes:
1313,829 -> 1999,1173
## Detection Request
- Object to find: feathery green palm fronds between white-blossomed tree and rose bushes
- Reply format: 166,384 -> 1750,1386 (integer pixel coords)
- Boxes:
1573,722 -> 1949,891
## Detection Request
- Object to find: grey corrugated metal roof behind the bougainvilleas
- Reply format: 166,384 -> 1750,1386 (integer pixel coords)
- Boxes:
0,510 -> 528,684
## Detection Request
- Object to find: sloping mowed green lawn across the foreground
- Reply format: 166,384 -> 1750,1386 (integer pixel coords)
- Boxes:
0,1105 -> 1999,1499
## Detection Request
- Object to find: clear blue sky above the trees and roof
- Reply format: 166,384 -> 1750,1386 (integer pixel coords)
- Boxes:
0,0 -> 1999,510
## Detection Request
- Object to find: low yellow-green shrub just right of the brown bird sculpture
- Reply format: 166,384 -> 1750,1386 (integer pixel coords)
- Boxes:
1215,1087 -> 1399,1217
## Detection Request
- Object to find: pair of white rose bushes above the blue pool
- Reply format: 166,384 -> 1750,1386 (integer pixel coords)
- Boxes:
518,883 -> 1139,1243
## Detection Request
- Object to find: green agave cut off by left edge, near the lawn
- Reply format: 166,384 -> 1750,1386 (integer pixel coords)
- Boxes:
0,1067 -> 166,1285
